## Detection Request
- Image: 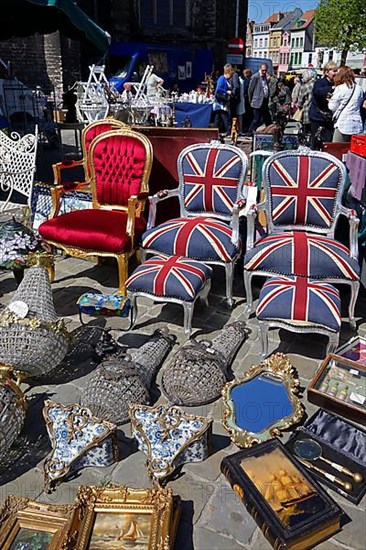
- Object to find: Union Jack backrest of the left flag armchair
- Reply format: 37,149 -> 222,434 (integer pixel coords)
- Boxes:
178,145 -> 246,216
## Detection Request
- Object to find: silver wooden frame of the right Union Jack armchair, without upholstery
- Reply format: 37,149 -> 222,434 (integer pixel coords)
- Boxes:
244,148 -> 360,329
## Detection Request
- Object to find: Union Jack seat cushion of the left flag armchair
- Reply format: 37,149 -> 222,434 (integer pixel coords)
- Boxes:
141,216 -> 241,263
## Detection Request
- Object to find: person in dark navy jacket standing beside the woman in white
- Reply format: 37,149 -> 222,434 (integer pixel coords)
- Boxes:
309,61 -> 338,149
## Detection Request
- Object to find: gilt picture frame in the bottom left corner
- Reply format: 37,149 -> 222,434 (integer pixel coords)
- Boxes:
0,495 -> 74,550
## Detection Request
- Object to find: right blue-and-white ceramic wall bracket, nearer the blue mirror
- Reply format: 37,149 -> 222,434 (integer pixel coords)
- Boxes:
130,405 -> 212,478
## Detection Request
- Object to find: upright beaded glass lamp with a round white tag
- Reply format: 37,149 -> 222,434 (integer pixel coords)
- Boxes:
0,266 -> 69,377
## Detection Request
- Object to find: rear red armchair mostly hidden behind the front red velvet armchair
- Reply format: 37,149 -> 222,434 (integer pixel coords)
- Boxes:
51,117 -> 126,217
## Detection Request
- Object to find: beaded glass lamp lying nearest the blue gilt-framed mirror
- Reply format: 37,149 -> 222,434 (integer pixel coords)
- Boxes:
162,322 -> 248,407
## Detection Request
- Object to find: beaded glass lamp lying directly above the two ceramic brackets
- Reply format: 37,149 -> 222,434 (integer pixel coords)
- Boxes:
81,331 -> 174,425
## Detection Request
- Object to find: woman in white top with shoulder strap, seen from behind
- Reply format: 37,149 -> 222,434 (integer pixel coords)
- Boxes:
328,66 -> 363,143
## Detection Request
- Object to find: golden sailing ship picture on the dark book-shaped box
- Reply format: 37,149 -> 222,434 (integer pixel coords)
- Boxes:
240,449 -> 325,528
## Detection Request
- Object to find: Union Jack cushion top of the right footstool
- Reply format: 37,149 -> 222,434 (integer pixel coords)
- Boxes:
257,277 -> 341,331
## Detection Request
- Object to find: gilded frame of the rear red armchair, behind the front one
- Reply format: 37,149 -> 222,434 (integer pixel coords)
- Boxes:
50,117 -> 129,218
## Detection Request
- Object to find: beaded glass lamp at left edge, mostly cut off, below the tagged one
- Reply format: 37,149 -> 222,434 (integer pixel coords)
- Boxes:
0,380 -> 27,460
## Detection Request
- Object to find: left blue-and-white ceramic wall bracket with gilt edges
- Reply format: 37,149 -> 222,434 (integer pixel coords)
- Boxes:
43,400 -> 117,487
